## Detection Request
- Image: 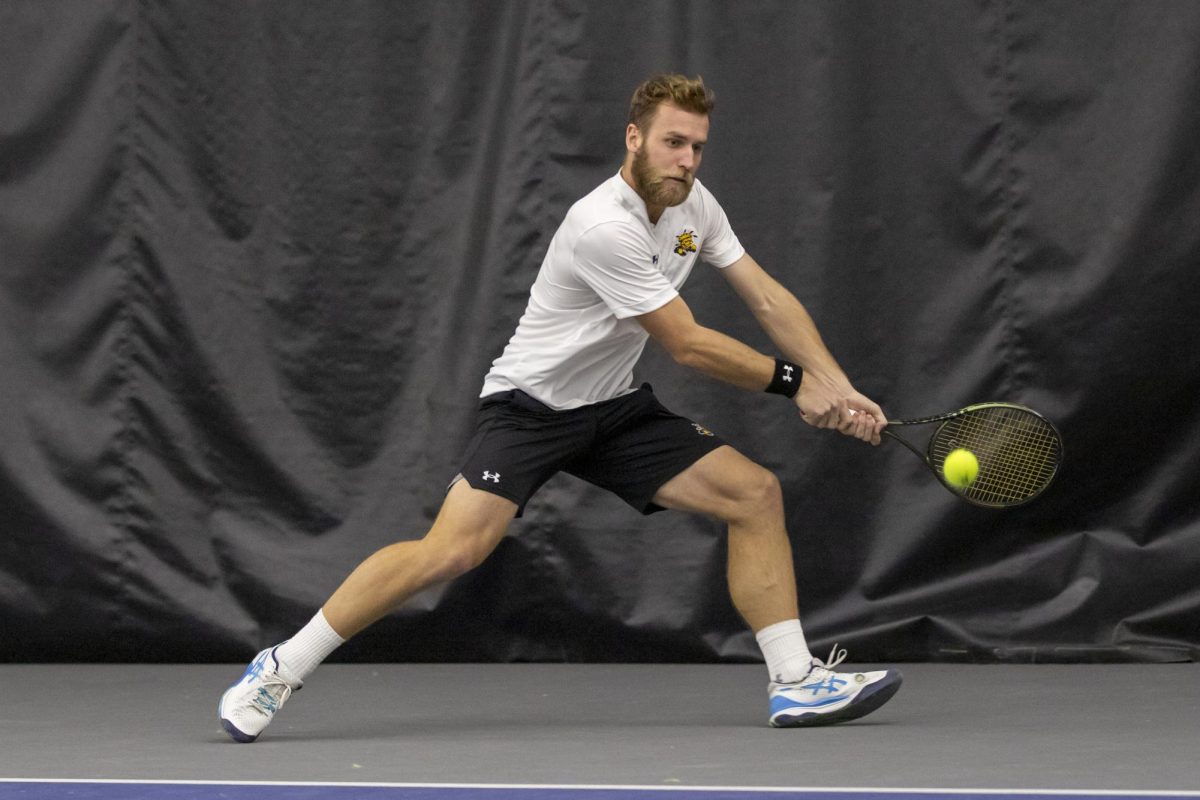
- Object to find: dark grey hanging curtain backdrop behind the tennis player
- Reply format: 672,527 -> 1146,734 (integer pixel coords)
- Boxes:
0,0 -> 1200,661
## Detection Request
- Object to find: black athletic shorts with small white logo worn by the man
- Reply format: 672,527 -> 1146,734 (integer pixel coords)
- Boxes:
461,384 -> 725,517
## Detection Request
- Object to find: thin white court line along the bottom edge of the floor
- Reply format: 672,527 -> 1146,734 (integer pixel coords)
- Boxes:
0,777 -> 1200,798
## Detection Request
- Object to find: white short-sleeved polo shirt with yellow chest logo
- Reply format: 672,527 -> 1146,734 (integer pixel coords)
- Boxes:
480,167 -> 745,410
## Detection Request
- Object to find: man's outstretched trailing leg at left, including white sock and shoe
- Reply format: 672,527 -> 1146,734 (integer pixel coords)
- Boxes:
220,481 -> 517,742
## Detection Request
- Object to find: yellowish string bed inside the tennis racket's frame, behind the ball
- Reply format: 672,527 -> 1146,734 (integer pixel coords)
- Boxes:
930,407 -> 1061,505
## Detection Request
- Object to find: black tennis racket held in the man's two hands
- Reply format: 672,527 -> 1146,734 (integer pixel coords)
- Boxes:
883,403 -> 1062,509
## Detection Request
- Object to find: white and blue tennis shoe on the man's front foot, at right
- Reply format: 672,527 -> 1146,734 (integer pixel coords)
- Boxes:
768,645 -> 902,728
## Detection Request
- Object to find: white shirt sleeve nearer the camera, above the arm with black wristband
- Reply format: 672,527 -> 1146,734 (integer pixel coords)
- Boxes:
574,223 -> 679,319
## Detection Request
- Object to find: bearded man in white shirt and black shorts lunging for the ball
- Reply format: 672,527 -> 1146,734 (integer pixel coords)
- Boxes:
220,76 -> 901,742
